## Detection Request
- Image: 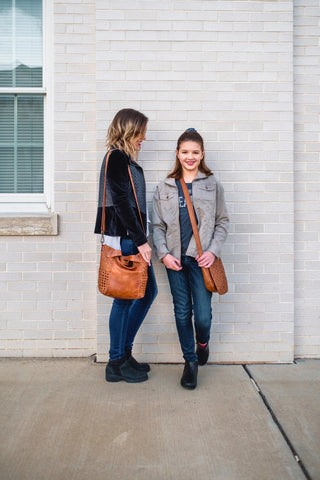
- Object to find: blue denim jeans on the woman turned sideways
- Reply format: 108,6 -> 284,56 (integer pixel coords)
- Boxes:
109,239 -> 158,360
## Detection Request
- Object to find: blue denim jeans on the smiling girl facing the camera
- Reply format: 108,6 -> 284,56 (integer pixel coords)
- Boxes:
167,255 -> 212,362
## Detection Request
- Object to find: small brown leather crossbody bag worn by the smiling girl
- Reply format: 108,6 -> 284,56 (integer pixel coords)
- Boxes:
180,178 -> 228,295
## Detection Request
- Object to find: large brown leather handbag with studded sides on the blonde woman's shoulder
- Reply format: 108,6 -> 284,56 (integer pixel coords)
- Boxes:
98,151 -> 148,300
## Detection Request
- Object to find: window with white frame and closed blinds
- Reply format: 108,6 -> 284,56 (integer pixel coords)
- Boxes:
0,0 -> 50,213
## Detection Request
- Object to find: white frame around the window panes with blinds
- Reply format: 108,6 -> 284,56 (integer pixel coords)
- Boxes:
0,0 -> 54,216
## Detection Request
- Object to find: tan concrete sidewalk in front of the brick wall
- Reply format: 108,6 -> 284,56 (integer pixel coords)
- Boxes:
0,359 -> 320,480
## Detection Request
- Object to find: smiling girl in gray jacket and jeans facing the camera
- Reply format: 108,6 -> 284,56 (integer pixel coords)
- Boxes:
153,128 -> 229,389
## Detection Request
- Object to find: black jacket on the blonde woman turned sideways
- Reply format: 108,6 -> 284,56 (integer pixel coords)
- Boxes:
94,150 -> 147,247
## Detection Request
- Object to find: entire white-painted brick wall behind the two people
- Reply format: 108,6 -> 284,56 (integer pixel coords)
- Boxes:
0,0 -> 320,362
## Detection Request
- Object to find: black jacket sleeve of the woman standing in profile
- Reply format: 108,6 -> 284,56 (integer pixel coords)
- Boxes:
107,150 -> 147,247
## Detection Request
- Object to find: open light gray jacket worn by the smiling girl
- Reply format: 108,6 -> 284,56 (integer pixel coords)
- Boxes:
153,172 -> 229,260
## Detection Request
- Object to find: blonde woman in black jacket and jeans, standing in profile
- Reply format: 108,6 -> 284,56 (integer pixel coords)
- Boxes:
95,109 -> 157,383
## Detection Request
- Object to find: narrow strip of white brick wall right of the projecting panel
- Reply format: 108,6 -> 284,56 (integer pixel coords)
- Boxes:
294,0 -> 320,357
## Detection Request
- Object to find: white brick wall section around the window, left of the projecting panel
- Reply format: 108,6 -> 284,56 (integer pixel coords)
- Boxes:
0,0 -> 96,356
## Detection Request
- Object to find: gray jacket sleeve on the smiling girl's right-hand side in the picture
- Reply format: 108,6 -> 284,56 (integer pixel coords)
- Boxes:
207,182 -> 229,257
